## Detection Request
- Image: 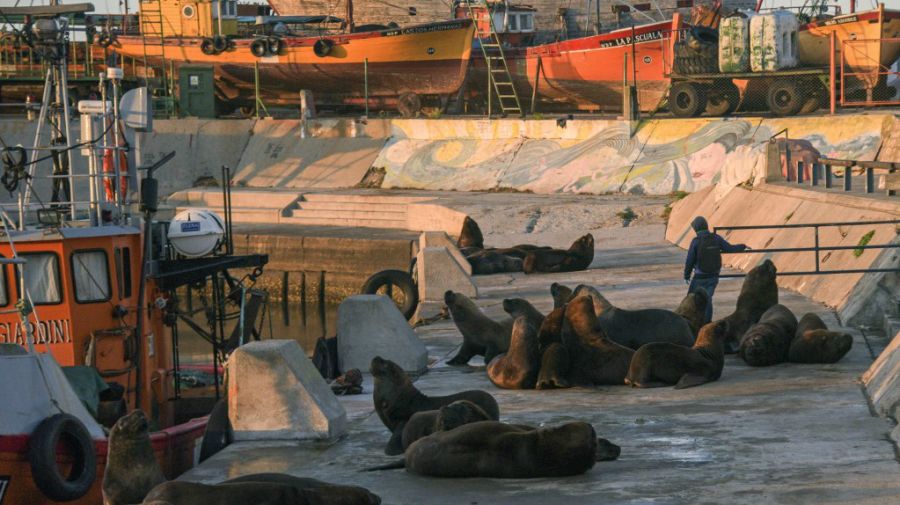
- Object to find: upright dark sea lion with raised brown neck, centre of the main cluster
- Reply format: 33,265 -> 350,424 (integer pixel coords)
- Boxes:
562,296 -> 634,385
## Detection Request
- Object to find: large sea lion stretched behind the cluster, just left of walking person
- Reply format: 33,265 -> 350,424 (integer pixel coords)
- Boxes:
570,284 -> 694,350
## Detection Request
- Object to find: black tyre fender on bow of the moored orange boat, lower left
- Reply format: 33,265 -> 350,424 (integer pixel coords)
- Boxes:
28,414 -> 97,501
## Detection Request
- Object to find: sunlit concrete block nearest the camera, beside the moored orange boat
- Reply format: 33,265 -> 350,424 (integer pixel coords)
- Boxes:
226,340 -> 347,441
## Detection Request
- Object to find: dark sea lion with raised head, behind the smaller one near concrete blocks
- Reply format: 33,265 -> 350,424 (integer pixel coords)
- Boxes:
370,356 -> 500,450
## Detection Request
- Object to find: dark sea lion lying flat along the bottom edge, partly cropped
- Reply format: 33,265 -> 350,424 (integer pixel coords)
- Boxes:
144,473 -> 381,505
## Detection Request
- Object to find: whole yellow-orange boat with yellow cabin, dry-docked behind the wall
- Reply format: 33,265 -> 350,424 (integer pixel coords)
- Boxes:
110,0 -> 473,111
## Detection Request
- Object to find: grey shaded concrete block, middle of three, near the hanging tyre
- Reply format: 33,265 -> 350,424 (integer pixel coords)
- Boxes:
338,295 -> 428,373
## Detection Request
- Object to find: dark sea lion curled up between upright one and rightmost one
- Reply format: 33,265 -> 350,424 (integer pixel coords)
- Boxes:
738,304 -> 797,366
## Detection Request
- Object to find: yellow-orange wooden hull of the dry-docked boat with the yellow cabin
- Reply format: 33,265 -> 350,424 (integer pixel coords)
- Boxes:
114,20 -> 473,103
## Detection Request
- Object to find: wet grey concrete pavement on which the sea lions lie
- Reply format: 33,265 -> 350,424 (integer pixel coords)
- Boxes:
181,225 -> 900,505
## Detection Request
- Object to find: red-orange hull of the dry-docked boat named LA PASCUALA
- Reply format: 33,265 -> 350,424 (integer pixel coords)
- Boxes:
473,21 -> 672,112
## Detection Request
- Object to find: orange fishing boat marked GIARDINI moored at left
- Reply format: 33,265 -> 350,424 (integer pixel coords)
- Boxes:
0,4 -> 267,505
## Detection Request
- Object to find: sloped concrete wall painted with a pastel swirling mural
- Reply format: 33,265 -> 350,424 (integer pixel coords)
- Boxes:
374,114 -> 894,194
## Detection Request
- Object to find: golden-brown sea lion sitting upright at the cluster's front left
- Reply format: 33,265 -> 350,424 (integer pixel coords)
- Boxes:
487,316 -> 543,389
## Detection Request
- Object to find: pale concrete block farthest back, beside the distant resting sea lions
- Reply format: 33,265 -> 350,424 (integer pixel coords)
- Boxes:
416,247 -> 478,301
